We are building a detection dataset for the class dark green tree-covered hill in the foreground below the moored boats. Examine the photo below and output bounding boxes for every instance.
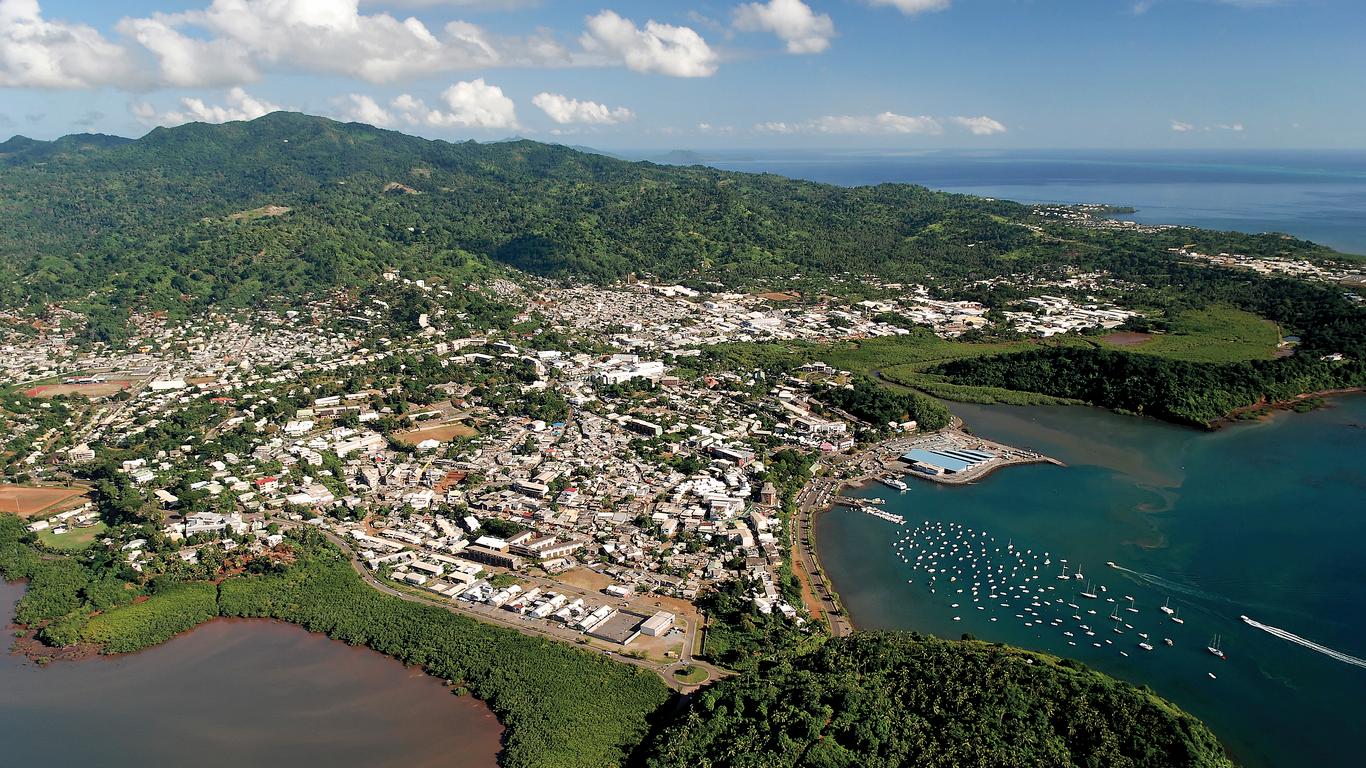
[642,633,1232,768]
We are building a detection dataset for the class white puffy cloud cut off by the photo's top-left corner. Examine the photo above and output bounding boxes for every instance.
[0,0,137,87]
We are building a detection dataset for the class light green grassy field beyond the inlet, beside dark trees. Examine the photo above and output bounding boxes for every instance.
[1101,306,1280,362]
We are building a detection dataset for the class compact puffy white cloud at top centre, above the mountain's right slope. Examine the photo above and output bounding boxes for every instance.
[579,11,716,78]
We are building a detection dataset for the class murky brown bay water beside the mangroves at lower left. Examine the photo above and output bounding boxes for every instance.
[0,582,503,768]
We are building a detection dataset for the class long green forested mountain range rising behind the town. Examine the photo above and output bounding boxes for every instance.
[0,112,1330,319]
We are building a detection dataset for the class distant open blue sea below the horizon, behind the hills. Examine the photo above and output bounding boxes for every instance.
[688,150,1366,256]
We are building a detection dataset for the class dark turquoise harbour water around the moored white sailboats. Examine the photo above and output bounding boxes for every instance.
[816,396,1366,768]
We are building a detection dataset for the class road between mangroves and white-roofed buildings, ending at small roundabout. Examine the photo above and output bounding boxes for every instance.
[307,529,731,693]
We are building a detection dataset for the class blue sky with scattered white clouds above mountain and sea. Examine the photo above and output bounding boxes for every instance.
[0,0,1366,150]
